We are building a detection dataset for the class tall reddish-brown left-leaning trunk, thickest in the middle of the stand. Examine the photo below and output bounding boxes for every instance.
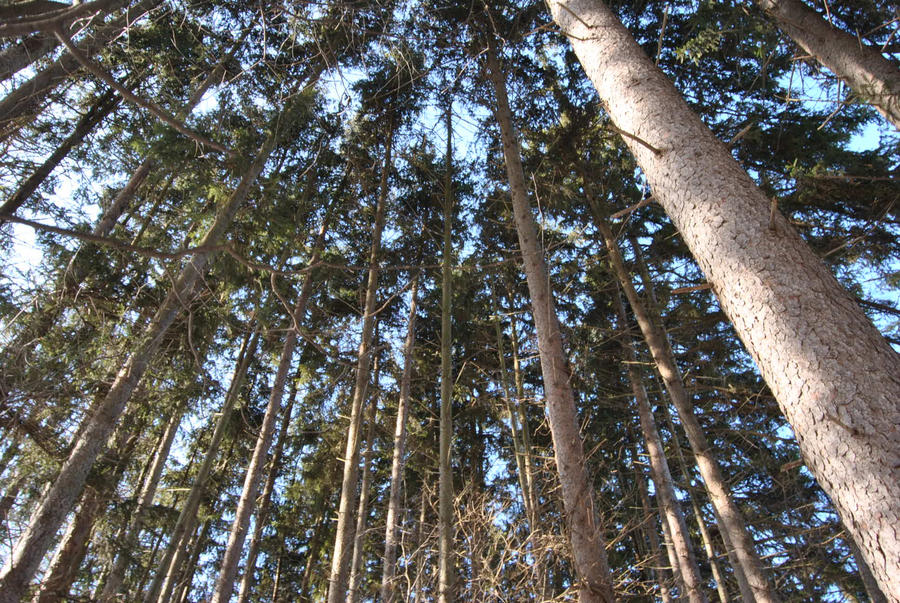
[487,48,615,603]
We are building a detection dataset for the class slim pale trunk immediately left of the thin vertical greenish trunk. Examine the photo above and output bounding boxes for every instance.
[381,272,420,603]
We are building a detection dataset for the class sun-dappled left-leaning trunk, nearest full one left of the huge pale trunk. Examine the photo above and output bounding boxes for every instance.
[589,217,778,603]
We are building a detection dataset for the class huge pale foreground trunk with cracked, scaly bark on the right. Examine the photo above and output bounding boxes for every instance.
[550,0,900,601]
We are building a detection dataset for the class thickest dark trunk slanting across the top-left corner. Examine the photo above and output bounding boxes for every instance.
[0,0,162,141]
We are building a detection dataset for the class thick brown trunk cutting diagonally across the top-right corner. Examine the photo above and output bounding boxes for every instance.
[756,0,900,129]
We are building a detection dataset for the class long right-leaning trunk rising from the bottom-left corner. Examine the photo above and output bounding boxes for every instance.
[0,112,277,603]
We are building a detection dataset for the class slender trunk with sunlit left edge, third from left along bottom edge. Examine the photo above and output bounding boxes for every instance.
[98,404,186,603]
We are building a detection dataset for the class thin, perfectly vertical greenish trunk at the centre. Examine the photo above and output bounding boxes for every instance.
[438,97,455,603]
